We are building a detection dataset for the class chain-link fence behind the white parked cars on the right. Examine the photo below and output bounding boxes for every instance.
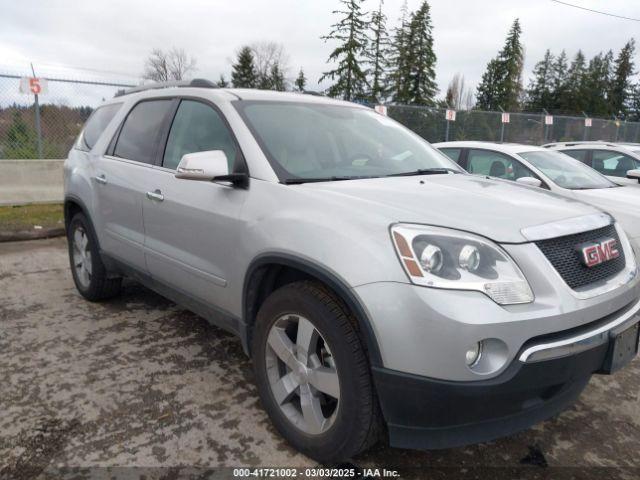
[387,105,640,145]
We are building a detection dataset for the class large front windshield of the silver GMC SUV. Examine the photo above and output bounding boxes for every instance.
[235,101,462,182]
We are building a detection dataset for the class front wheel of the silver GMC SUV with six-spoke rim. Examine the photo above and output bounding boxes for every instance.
[252,282,381,464]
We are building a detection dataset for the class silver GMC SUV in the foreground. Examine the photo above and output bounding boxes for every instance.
[65,80,640,462]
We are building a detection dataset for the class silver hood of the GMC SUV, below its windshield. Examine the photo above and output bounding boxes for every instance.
[296,174,598,243]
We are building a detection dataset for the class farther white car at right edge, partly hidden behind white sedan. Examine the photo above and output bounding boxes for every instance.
[543,142,640,186]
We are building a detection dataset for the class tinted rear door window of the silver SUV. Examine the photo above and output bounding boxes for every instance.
[113,99,172,163]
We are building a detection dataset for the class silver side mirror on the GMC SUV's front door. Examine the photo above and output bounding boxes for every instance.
[175,150,249,188]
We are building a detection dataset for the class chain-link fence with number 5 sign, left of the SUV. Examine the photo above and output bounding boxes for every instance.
[0,73,135,160]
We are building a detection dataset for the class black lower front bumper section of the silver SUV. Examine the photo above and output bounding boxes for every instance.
[373,316,638,449]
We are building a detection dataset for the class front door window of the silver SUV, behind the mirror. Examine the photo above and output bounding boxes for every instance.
[162,100,236,172]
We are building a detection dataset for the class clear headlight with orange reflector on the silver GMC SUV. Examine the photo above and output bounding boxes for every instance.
[391,224,533,305]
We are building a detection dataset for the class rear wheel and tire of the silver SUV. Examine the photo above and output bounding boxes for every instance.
[67,213,122,302]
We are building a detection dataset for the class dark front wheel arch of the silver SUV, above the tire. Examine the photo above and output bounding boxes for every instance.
[242,253,382,366]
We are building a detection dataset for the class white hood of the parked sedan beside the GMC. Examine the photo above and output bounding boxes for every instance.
[573,186,640,238]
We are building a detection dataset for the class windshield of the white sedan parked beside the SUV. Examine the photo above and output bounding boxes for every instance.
[518,151,617,190]
